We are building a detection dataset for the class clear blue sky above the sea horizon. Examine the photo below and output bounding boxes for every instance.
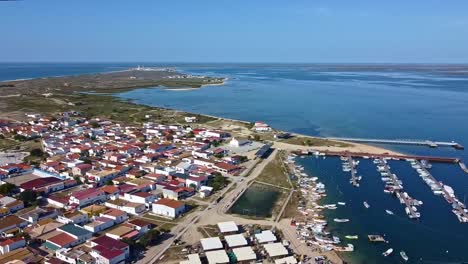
[0,0,468,63]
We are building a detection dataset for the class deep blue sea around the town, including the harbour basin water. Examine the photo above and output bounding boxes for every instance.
[0,63,468,263]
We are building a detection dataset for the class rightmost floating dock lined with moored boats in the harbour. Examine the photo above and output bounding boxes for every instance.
[411,161,468,223]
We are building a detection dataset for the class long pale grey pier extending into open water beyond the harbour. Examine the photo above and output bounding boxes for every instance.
[327,137,464,149]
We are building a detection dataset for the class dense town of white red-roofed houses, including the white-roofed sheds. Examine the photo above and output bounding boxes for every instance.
[0,108,352,264]
